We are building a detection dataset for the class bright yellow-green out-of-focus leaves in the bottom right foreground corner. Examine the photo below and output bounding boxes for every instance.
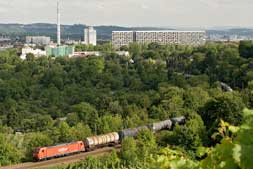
[200,110,253,169]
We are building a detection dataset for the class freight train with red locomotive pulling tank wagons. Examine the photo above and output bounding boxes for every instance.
[33,116,185,161]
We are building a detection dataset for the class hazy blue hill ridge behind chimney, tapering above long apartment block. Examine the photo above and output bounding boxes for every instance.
[0,23,172,40]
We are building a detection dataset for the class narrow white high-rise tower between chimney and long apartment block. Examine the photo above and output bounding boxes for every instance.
[84,27,97,46]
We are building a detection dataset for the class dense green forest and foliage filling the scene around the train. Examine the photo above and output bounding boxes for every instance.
[0,41,253,169]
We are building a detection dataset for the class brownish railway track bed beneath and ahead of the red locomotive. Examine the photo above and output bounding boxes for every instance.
[1,145,121,169]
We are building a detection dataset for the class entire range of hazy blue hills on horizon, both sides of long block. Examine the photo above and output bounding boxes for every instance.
[0,23,253,41]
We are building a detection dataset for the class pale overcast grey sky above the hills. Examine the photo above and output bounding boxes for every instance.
[0,0,253,28]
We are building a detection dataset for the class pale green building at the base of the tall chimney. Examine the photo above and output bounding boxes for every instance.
[45,45,75,57]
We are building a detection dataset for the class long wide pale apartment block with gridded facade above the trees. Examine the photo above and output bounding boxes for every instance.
[112,30,206,48]
